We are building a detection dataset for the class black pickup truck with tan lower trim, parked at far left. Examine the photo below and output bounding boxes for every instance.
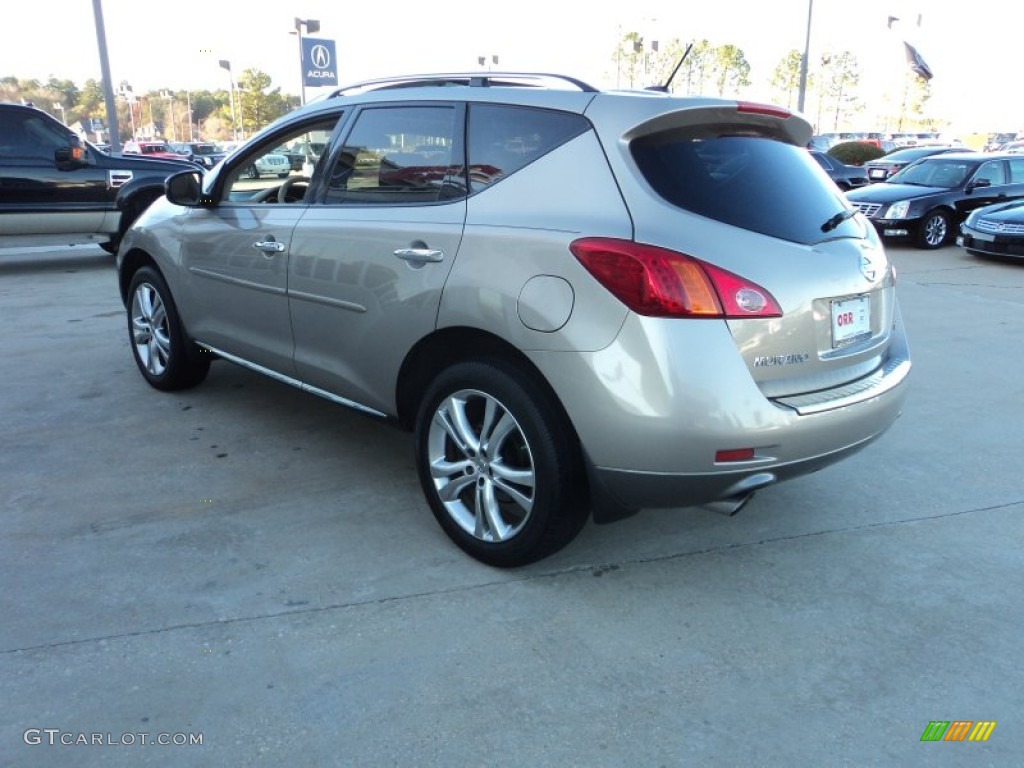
[0,103,198,253]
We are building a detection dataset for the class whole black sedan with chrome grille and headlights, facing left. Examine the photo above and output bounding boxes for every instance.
[846,153,1024,248]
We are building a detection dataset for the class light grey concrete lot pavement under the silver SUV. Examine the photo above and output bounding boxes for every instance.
[0,247,1024,767]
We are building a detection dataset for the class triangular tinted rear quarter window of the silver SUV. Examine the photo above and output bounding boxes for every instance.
[468,104,590,193]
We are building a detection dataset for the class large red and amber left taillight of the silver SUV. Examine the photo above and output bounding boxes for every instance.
[569,238,782,317]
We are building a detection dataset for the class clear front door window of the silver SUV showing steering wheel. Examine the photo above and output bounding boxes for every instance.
[221,116,340,203]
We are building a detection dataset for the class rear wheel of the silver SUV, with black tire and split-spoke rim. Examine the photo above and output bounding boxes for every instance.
[416,360,589,567]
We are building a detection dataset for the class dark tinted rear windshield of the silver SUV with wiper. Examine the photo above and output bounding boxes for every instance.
[631,133,863,244]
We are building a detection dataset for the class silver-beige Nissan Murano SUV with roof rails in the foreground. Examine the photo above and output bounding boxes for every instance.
[118,73,910,566]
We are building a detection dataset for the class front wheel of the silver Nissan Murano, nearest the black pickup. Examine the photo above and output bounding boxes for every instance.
[128,266,210,391]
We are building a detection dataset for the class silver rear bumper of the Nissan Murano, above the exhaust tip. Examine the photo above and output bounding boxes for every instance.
[535,313,910,519]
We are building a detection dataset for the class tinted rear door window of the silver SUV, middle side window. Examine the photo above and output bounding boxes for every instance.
[325,104,466,205]
